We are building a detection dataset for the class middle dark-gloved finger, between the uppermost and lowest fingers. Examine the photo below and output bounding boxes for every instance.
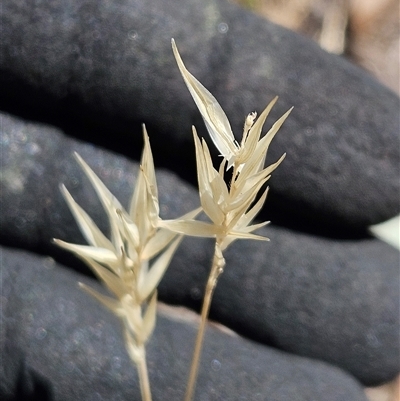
[0,116,400,385]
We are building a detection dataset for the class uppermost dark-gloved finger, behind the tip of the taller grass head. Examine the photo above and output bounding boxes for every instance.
[0,0,400,228]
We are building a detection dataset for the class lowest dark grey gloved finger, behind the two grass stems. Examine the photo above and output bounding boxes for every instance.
[0,248,367,401]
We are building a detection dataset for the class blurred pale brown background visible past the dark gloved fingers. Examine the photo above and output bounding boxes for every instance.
[231,0,400,401]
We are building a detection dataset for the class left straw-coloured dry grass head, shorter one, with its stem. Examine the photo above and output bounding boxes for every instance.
[54,127,200,400]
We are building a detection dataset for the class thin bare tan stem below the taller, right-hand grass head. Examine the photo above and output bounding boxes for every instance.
[185,241,225,401]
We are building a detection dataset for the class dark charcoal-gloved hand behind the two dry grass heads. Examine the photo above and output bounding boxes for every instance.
[0,0,399,400]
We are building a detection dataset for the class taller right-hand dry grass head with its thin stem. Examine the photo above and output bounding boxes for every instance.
[166,39,292,401]
